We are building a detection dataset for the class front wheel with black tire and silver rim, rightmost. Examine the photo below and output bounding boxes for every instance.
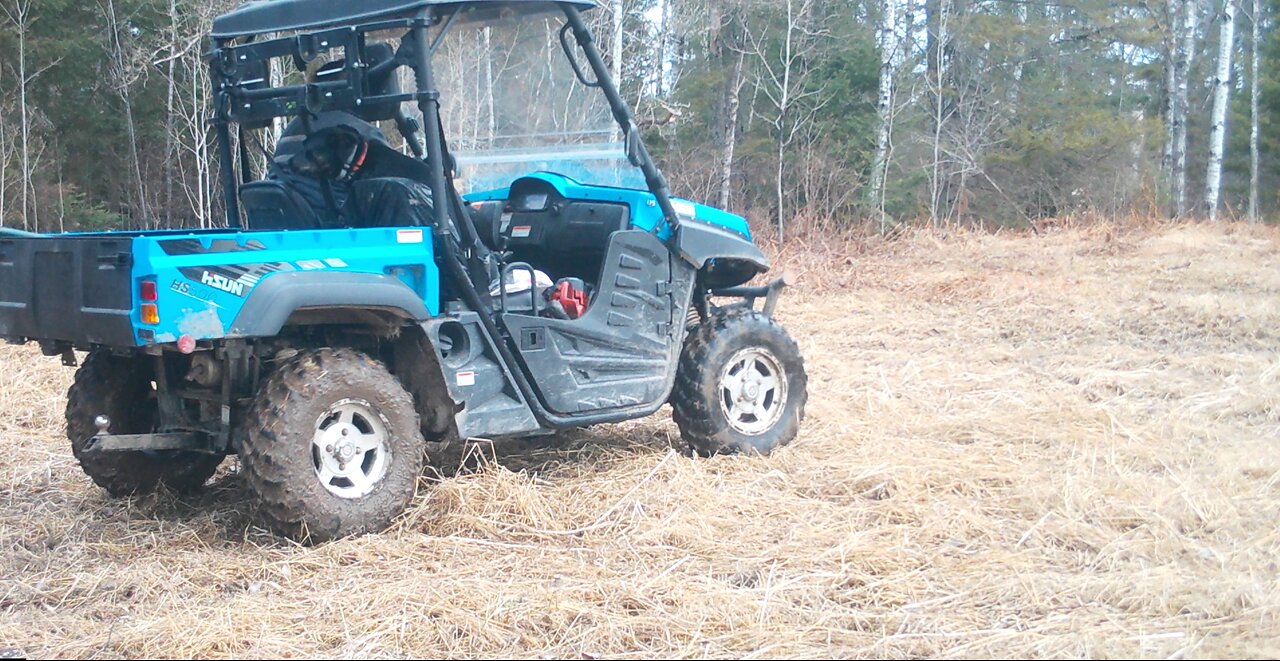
[671,310,808,457]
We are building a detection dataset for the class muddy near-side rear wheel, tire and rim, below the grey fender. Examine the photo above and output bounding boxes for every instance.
[241,348,426,543]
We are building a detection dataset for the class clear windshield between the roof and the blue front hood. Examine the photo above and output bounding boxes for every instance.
[434,17,646,193]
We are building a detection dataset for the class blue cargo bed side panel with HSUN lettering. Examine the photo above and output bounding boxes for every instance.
[133,228,440,346]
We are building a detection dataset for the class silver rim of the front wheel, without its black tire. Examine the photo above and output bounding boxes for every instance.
[719,347,787,436]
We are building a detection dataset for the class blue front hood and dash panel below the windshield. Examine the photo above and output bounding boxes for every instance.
[463,172,751,241]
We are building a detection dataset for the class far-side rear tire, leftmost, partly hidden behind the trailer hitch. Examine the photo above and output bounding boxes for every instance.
[67,351,223,497]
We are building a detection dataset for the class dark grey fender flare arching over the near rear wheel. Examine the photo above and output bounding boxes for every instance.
[229,272,431,337]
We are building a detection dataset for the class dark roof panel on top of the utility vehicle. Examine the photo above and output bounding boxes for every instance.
[212,0,595,38]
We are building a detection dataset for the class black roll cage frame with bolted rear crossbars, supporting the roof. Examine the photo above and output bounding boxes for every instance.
[206,3,680,237]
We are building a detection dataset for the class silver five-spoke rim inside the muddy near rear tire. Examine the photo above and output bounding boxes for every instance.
[311,400,392,500]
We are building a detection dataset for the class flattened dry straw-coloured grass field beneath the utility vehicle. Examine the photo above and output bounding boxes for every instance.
[0,225,1280,658]
